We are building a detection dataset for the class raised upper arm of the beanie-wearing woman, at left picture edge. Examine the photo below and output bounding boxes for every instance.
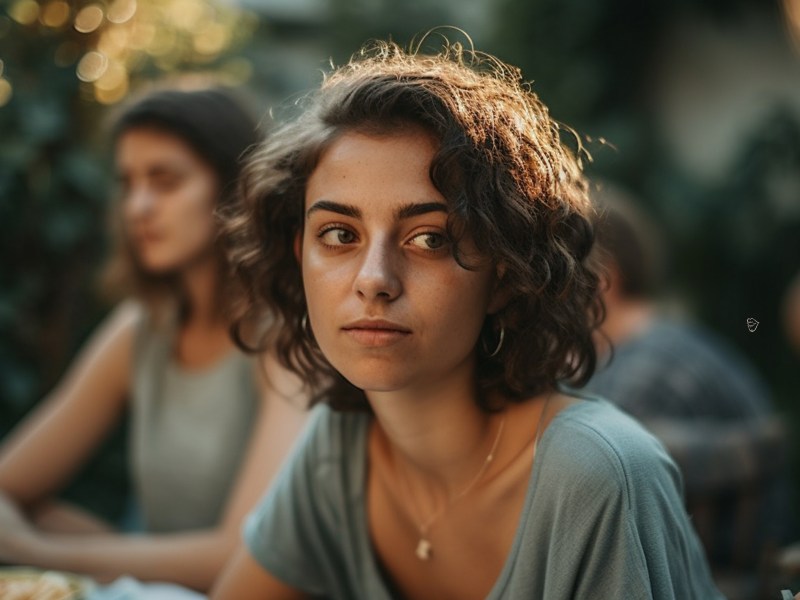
[0,303,140,510]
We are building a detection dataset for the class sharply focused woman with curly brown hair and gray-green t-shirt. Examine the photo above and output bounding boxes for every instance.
[212,43,720,600]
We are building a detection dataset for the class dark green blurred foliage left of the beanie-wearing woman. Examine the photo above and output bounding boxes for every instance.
[0,4,127,518]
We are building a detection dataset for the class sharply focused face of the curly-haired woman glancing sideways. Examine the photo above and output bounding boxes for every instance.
[298,129,499,392]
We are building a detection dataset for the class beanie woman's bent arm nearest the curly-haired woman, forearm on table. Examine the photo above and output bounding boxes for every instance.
[0,352,306,590]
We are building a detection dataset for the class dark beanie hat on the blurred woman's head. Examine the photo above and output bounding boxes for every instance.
[112,88,258,202]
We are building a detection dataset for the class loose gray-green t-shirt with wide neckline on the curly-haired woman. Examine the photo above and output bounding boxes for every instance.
[245,400,722,600]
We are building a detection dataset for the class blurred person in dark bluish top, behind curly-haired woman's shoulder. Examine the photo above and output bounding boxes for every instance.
[586,184,794,600]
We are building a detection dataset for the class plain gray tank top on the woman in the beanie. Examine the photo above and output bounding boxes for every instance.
[130,318,258,532]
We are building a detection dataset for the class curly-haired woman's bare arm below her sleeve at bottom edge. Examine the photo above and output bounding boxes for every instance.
[209,546,308,600]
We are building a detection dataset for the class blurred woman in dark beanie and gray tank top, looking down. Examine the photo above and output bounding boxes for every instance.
[0,84,304,589]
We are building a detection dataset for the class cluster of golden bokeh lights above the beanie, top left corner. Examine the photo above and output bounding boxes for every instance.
[0,0,258,104]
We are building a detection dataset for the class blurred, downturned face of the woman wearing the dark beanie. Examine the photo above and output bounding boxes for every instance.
[116,128,219,273]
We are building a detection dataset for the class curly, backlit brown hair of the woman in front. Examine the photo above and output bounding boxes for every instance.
[226,36,603,410]
